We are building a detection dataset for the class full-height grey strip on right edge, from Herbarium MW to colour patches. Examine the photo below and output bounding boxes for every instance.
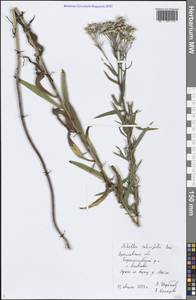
[186,0,196,300]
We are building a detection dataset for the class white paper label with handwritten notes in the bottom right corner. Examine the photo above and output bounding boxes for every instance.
[114,242,186,299]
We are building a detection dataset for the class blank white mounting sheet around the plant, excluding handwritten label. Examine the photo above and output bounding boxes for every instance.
[2,1,186,299]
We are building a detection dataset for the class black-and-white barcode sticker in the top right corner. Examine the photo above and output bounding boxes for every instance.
[156,8,178,22]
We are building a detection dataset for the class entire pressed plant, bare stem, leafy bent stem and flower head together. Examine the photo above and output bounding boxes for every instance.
[11,8,156,248]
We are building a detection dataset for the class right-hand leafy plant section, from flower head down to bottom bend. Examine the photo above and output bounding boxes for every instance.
[85,16,157,226]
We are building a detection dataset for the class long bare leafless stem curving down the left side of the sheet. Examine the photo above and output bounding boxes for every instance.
[12,9,71,249]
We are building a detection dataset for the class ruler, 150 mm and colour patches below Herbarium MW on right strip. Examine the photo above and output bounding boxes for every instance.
[186,87,196,299]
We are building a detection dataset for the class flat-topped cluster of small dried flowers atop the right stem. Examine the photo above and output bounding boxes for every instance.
[85,17,136,59]
